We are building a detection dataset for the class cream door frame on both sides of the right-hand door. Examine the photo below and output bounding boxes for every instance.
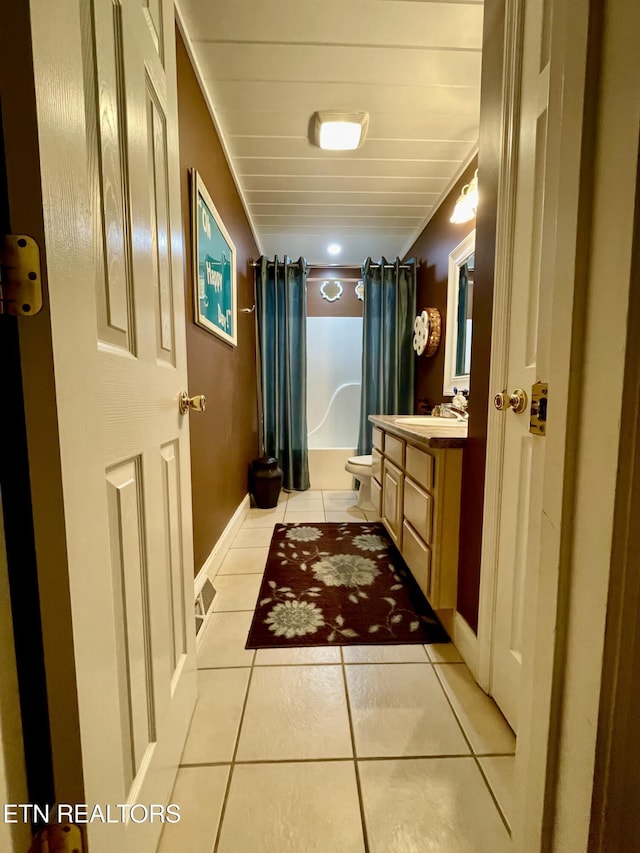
[478,0,640,853]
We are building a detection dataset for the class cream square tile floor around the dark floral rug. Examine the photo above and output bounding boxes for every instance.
[159,491,515,853]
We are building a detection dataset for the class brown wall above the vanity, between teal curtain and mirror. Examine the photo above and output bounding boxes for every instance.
[406,164,478,409]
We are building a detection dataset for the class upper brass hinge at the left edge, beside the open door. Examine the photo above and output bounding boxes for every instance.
[0,234,42,317]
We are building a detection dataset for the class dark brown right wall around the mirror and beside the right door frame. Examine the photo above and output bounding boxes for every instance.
[407,0,504,631]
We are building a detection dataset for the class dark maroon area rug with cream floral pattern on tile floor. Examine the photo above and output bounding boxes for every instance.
[246,522,449,649]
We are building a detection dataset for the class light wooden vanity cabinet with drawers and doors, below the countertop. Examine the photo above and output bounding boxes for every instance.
[372,427,462,610]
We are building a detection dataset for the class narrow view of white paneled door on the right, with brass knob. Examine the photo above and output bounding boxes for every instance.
[490,3,549,730]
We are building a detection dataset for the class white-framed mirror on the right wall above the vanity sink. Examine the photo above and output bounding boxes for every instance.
[443,229,476,396]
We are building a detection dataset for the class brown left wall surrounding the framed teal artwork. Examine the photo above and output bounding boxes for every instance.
[176,32,259,573]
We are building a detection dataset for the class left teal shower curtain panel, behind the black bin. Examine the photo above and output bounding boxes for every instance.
[256,257,309,491]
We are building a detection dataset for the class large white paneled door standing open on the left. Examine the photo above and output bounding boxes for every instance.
[23,0,196,853]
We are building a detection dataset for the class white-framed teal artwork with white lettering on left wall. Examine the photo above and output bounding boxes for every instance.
[191,169,238,347]
